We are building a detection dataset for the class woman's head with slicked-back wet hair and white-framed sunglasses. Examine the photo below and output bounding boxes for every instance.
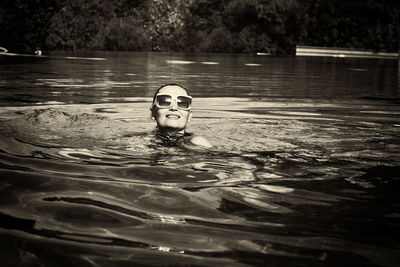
[150,84,192,132]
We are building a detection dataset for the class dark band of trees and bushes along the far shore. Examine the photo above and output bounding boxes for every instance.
[0,0,400,54]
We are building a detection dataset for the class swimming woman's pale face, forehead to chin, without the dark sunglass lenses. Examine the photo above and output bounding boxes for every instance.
[151,85,192,133]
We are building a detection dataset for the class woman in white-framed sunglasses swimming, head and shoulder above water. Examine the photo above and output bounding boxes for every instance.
[150,84,212,148]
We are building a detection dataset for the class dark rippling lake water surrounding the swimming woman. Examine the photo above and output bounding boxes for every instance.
[0,53,400,266]
